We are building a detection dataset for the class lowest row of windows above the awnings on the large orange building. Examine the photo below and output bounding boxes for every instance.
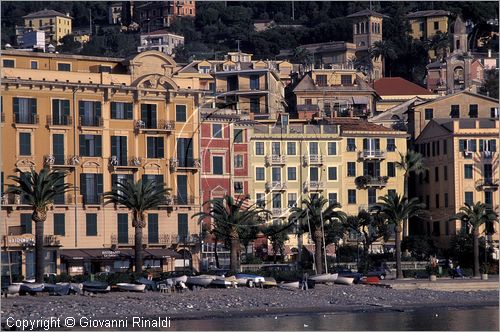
[20,213,189,243]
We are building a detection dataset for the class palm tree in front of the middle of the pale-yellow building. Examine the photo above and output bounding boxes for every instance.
[289,196,346,274]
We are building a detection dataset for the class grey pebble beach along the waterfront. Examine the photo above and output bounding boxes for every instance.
[1,285,499,325]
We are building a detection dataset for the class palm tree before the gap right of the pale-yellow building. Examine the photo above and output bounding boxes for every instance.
[374,192,424,279]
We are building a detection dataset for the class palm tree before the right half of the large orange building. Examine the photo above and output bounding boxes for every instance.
[104,180,168,272]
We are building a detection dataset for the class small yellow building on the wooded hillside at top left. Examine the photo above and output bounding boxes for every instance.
[17,9,73,46]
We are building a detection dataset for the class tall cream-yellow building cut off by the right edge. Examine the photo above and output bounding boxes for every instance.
[415,118,500,254]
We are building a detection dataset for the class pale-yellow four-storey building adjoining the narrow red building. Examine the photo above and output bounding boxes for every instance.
[249,118,407,255]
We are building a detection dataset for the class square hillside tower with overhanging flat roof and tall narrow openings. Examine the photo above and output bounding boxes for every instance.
[347,9,388,79]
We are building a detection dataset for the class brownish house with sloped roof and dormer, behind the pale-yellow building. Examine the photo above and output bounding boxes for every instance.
[293,69,379,117]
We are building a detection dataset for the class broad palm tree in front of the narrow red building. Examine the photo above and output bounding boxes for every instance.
[192,195,269,271]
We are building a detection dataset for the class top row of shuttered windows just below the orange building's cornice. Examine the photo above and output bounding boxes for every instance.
[12,97,187,123]
